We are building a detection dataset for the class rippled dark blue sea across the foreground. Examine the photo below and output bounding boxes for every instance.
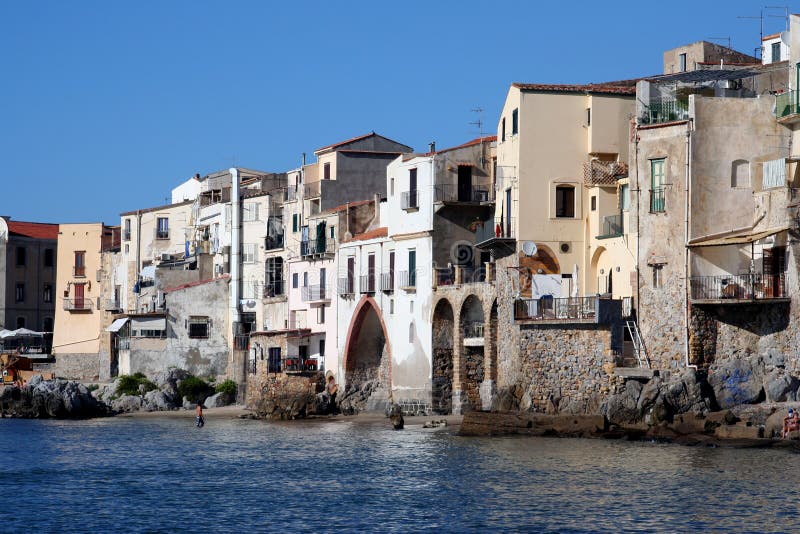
[0,416,800,532]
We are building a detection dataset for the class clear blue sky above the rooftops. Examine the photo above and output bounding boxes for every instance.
[0,0,791,224]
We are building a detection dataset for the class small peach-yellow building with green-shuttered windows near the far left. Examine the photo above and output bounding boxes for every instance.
[53,223,119,379]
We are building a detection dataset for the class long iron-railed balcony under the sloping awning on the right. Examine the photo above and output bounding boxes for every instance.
[689,273,789,304]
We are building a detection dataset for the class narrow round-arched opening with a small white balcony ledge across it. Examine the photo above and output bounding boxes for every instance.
[459,295,486,411]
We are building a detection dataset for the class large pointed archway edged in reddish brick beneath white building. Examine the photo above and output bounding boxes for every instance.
[342,296,392,411]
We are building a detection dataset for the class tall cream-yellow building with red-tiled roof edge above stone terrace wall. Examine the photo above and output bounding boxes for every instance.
[477,81,636,297]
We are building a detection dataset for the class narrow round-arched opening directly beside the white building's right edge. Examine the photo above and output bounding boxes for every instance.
[431,299,454,414]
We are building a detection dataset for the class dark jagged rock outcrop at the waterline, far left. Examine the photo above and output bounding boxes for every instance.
[0,375,111,419]
